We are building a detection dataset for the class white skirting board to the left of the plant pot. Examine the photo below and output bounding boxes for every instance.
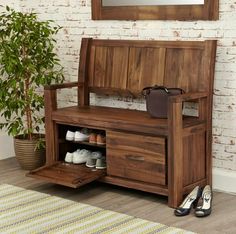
[0,134,15,160]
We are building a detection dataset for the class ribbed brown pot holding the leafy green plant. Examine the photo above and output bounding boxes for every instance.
[14,136,46,170]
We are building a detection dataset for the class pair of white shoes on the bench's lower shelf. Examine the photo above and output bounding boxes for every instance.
[65,149,91,164]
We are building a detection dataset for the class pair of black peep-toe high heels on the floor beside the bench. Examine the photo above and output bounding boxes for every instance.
[174,185,213,217]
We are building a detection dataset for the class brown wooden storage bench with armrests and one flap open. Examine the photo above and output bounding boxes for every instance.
[30,38,216,207]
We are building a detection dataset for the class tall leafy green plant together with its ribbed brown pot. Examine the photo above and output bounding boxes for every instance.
[0,7,64,170]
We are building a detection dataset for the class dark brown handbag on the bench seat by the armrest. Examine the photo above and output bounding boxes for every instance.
[142,85,184,118]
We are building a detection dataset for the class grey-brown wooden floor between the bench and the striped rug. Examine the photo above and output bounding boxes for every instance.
[0,158,236,234]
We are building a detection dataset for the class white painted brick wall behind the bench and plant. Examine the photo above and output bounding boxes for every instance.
[1,0,236,171]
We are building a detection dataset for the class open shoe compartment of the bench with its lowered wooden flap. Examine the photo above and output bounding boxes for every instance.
[27,123,106,188]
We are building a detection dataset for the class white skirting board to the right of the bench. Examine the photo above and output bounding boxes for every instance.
[212,168,236,194]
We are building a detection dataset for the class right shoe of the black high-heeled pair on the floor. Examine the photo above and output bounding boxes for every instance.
[195,185,212,217]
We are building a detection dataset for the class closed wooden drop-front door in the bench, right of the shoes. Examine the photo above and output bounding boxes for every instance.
[107,132,166,185]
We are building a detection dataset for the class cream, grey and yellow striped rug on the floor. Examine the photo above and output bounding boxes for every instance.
[0,184,195,234]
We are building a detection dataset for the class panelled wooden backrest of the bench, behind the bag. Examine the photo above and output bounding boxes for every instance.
[79,38,216,105]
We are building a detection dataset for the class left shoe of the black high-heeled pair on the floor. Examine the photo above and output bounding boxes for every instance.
[174,186,201,216]
